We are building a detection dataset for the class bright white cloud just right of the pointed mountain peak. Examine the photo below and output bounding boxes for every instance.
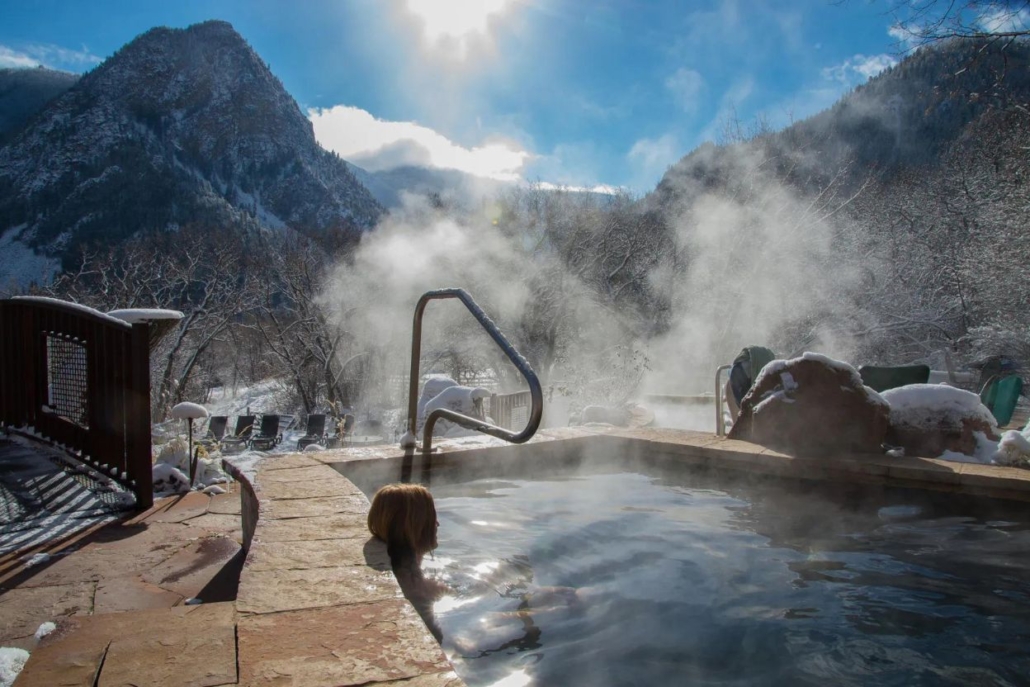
[308,105,531,181]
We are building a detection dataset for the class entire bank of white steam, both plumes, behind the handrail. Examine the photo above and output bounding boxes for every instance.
[323,143,857,420]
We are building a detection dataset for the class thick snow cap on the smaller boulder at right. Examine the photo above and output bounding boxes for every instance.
[883,384,997,430]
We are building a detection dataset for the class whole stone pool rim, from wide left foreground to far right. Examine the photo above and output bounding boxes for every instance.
[219,427,1030,687]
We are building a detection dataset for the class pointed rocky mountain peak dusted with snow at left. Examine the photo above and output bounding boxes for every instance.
[0,22,383,271]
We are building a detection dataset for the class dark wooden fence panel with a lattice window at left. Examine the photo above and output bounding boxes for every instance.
[0,298,153,509]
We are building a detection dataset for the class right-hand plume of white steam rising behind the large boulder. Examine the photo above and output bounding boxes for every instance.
[645,146,857,393]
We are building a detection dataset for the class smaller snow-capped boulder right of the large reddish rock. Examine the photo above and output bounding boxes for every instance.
[883,384,998,462]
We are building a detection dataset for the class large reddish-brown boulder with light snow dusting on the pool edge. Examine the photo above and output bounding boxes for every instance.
[729,353,890,455]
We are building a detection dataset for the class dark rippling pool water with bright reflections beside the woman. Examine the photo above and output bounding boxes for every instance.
[425,474,1030,687]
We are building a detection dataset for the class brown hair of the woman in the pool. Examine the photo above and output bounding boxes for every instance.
[369,484,437,556]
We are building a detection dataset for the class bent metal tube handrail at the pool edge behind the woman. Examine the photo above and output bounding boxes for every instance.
[401,288,544,453]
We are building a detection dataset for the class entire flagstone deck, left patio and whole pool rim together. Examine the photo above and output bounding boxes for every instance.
[10,430,1030,687]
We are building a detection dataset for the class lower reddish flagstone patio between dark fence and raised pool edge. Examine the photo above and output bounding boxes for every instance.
[0,485,243,651]
